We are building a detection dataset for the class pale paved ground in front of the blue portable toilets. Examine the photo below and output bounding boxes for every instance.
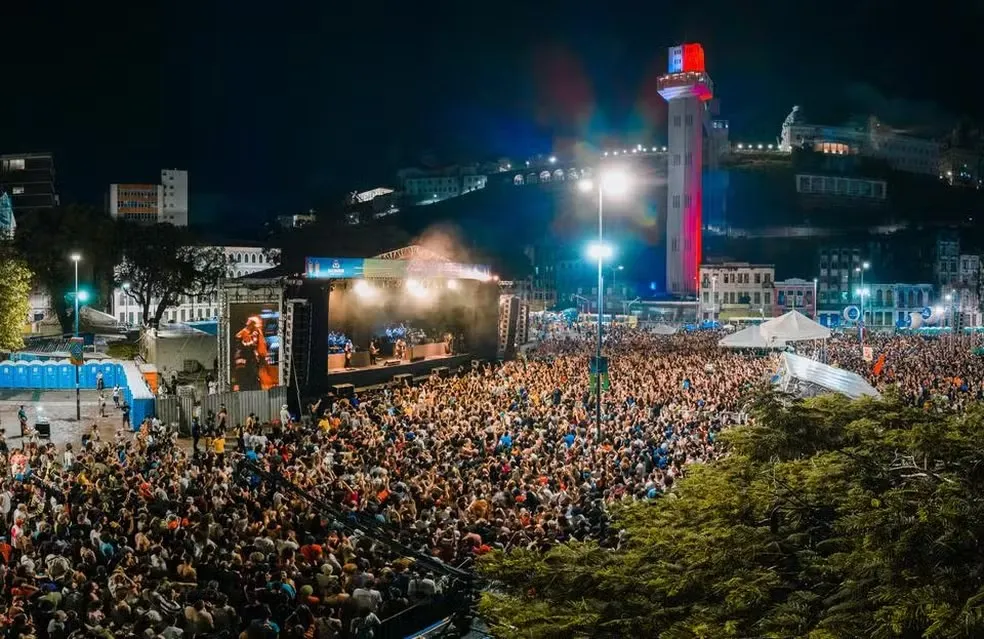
[0,388,136,450]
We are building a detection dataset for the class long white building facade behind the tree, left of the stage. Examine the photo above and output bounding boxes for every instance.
[111,246,279,326]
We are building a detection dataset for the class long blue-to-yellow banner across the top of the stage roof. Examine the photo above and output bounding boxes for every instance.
[304,257,491,281]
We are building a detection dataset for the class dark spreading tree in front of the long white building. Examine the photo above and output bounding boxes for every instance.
[114,224,226,328]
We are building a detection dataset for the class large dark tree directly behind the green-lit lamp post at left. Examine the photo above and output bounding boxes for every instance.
[14,204,120,333]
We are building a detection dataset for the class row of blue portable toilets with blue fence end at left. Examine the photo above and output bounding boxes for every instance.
[0,359,154,429]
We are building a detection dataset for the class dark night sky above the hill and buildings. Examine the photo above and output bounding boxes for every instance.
[0,0,984,222]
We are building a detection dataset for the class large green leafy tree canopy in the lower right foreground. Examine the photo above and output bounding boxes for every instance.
[479,394,984,639]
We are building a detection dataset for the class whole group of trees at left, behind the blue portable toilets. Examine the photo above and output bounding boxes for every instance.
[6,204,225,338]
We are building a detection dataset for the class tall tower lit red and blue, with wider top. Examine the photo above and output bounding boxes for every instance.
[658,44,714,295]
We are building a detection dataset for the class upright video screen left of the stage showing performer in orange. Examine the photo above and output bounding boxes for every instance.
[229,302,280,391]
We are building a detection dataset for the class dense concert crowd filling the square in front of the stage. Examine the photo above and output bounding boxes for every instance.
[0,325,984,639]
